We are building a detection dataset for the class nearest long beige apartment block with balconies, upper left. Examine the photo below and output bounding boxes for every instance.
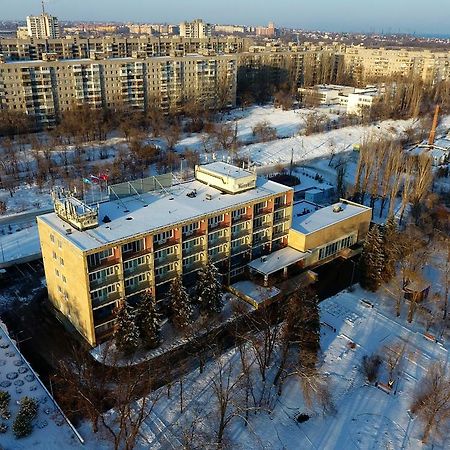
[0,55,237,125]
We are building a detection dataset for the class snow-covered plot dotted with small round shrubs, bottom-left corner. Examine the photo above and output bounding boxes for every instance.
[0,321,83,450]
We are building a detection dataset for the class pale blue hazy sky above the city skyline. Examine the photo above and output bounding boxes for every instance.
[0,0,450,34]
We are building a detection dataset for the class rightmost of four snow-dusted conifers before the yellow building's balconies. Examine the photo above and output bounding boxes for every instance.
[197,263,223,315]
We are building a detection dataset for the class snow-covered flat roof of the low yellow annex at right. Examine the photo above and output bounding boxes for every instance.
[292,201,370,234]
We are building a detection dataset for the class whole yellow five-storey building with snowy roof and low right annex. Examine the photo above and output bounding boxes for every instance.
[38,162,371,346]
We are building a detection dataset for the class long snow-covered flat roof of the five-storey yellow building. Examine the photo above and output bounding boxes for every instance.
[38,178,292,251]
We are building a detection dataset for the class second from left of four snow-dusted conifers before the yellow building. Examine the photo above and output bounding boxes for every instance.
[136,292,161,348]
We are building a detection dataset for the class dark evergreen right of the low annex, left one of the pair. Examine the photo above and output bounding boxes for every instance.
[359,225,384,292]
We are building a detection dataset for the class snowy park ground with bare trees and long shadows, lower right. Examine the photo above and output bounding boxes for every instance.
[86,288,450,450]
